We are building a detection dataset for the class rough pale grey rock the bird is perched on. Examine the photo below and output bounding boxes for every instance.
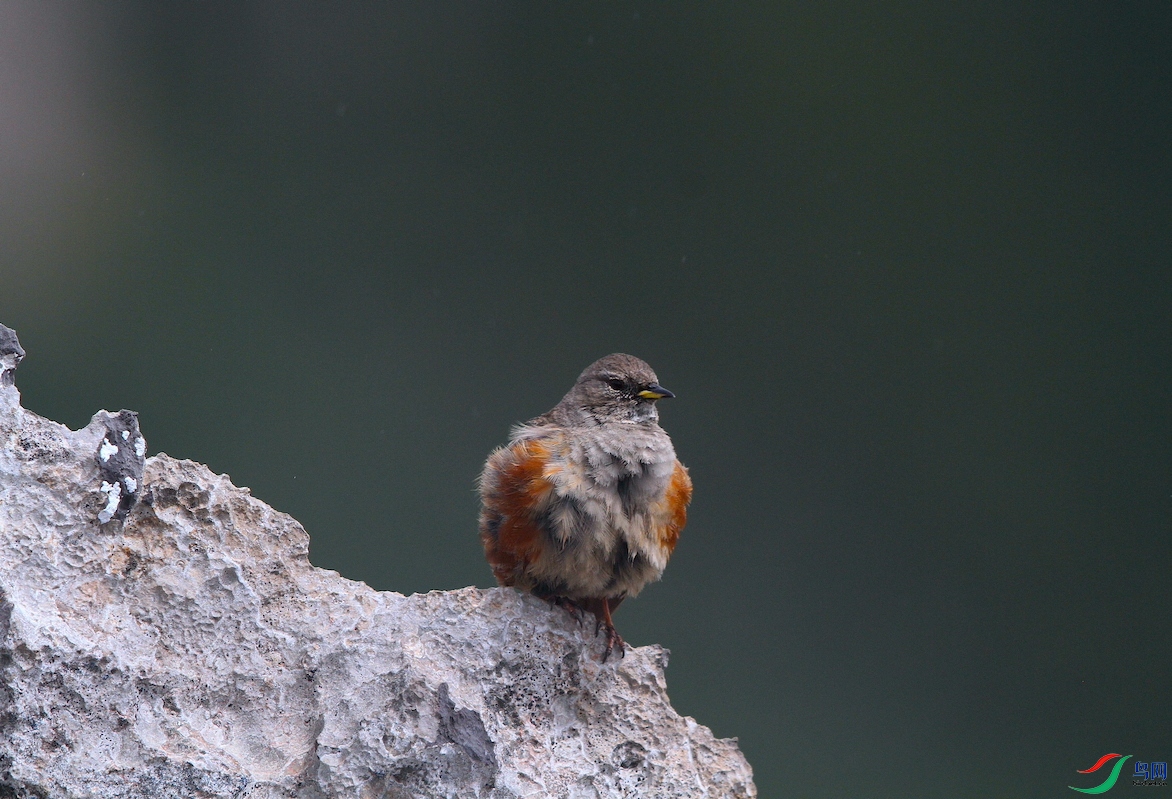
[0,326,756,799]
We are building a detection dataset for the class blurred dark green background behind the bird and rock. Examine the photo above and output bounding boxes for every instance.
[0,0,1172,799]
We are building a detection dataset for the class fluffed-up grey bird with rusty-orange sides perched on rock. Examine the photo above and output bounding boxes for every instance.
[478,353,691,663]
